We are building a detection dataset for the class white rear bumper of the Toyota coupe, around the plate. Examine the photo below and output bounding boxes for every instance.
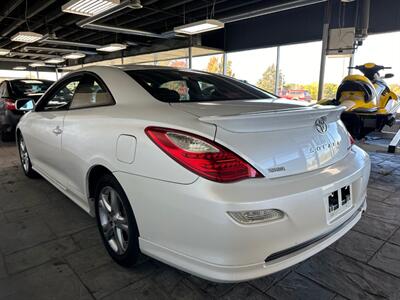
[115,146,370,282]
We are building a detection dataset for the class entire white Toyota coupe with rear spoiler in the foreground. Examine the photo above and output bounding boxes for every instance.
[16,66,370,282]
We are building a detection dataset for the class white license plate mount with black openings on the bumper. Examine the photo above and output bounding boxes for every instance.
[327,185,353,221]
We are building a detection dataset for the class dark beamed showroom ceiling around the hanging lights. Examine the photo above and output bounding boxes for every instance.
[0,0,310,67]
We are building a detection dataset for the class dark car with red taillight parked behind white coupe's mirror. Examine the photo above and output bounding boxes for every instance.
[0,79,53,141]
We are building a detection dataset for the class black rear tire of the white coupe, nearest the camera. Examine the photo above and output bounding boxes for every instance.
[95,174,140,267]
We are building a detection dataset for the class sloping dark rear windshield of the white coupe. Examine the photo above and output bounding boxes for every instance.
[126,69,276,102]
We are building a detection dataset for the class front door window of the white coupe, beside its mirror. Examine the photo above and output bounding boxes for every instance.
[39,78,79,111]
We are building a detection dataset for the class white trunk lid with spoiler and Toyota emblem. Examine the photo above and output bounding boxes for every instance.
[171,99,351,178]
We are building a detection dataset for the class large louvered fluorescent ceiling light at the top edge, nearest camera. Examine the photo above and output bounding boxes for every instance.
[61,0,120,17]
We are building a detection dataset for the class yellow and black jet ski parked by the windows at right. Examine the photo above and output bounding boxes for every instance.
[318,63,400,139]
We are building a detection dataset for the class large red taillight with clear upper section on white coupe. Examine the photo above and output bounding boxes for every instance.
[145,127,263,182]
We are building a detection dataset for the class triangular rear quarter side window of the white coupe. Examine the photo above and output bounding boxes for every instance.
[70,75,115,109]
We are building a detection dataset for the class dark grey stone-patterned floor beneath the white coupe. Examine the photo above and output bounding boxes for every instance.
[0,144,400,300]
